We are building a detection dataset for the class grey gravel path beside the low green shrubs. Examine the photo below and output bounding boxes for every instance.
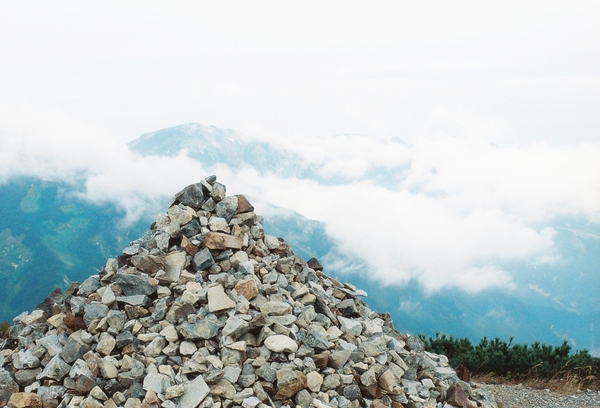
[473,383,600,408]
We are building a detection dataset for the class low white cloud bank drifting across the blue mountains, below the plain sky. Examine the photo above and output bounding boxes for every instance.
[0,108,600,292]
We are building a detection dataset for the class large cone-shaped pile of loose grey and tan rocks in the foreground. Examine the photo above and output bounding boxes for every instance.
[0,176,496,408]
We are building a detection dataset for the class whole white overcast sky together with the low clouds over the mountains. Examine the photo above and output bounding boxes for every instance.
[0,0,600,291]
